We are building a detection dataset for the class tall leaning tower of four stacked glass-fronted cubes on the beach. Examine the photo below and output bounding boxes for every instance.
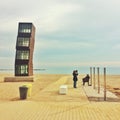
[15,23,35,76]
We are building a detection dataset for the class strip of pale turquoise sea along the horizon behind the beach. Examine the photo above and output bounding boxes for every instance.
[0,66,120,75]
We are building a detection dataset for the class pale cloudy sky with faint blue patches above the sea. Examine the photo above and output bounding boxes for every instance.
[0,0,120,68]
